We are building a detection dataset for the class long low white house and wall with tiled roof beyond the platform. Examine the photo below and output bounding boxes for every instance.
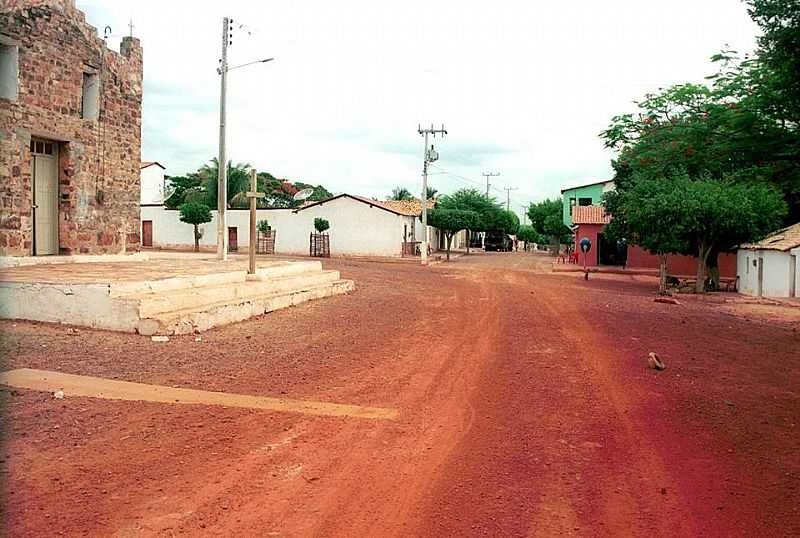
[141,194,465,257]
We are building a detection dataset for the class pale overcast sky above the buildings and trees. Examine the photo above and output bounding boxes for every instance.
[77,0,757,218]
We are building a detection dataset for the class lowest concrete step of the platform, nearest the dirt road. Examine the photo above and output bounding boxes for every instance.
[137,278,354,336]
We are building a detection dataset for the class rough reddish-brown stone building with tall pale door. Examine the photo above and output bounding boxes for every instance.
[0,0,142,256]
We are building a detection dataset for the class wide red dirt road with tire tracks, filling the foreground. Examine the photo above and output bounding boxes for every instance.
[0,253,800,536]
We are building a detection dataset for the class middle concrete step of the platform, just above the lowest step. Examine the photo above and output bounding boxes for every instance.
[128,271,339,318]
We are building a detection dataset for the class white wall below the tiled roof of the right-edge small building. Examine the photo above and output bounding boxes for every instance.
[736,249,797,297]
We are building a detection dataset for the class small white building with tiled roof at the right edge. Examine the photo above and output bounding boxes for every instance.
[736,223,800,297]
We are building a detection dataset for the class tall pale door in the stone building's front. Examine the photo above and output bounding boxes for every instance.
[31,140,58,256]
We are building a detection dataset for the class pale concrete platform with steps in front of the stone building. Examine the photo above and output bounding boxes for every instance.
[0,253,354,336]
